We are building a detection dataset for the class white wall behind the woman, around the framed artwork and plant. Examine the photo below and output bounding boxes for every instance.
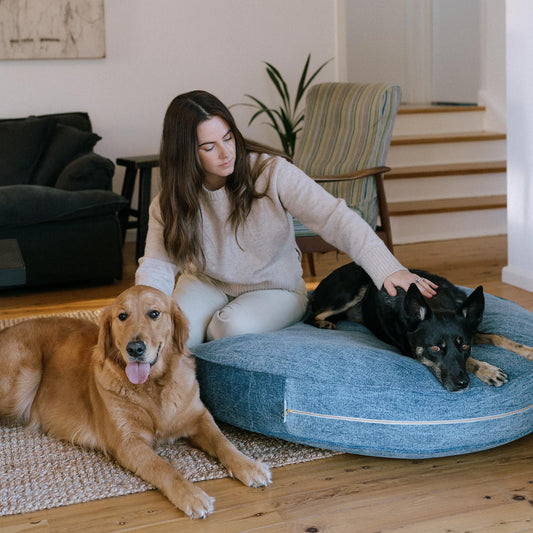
[0,0,338,184]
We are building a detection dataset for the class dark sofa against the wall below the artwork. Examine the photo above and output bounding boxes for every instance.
[0,112,128,286]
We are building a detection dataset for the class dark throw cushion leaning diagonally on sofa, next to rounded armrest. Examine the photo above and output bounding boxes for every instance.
[30,123,101,188]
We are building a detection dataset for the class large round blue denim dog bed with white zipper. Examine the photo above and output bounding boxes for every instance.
[194,294,533,458]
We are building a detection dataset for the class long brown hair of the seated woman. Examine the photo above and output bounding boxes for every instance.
[159,91,286,270]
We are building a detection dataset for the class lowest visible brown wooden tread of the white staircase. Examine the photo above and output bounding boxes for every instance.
[388,194,507,216]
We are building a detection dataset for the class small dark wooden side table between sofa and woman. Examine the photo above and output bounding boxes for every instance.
[116,155,159,259]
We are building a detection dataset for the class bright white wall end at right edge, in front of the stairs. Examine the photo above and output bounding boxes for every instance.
[503,0,533,291]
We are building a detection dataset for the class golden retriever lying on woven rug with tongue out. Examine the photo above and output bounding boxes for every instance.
[0,286,270,518]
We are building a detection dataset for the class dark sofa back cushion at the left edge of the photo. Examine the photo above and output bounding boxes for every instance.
[0,118,54,185]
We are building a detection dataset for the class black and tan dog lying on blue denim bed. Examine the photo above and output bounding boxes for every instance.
[306,263,533,392]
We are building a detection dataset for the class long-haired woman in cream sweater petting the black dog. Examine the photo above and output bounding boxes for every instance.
[136,91,436,347]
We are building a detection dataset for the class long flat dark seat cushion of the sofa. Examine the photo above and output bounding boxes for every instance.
[0,185,128,227]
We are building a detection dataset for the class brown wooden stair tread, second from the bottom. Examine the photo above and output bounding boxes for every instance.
[385,161,507,180]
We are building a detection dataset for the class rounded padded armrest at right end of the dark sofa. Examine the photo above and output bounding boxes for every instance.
[55,152,115,191]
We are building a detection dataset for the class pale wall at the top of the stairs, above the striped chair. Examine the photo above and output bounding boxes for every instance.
[346,0,505,113]
